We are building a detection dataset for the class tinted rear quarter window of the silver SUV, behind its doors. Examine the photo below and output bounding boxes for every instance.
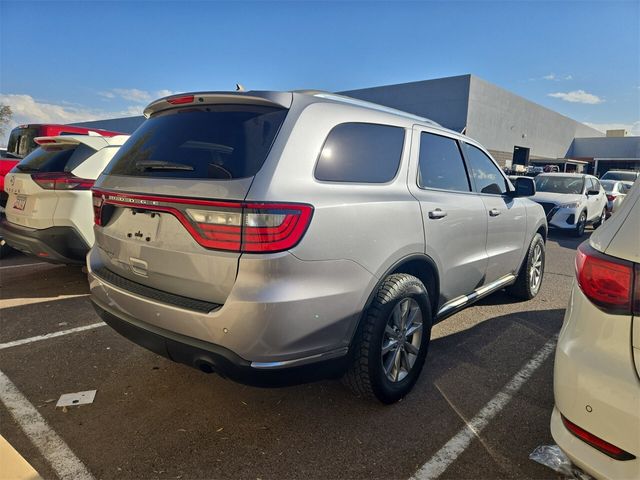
[315,123,404,183]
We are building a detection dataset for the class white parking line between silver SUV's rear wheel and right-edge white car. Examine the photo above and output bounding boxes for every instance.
[411,335,558,480]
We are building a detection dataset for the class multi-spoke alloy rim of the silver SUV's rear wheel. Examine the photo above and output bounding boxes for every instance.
[381,297,423,383]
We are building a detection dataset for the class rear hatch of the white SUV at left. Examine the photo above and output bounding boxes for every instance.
[5,136,106,229]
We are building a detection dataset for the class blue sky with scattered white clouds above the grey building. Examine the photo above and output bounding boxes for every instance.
[0,0,640,143]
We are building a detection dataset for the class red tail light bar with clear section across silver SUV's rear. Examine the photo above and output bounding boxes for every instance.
[93,190,313,253]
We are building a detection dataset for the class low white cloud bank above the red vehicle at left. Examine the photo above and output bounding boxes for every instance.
[0,94,142,145]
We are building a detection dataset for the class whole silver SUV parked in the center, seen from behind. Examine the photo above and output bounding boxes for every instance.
[87,92,547,403]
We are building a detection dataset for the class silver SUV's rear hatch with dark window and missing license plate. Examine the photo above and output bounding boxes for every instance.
[92,94,291,304]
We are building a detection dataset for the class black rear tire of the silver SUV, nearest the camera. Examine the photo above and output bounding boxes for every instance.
[343,273,432,404]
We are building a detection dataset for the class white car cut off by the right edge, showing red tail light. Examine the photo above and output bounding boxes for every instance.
[551,182,640,479]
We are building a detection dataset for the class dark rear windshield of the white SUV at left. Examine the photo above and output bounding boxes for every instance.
[16,144,96,172]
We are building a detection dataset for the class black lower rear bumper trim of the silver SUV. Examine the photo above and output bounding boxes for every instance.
[93,300,347,387]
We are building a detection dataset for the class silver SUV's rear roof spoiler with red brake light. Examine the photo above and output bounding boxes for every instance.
[143,91,293,118]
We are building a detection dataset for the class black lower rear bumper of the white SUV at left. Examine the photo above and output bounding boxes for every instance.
[0,218,89,265]
